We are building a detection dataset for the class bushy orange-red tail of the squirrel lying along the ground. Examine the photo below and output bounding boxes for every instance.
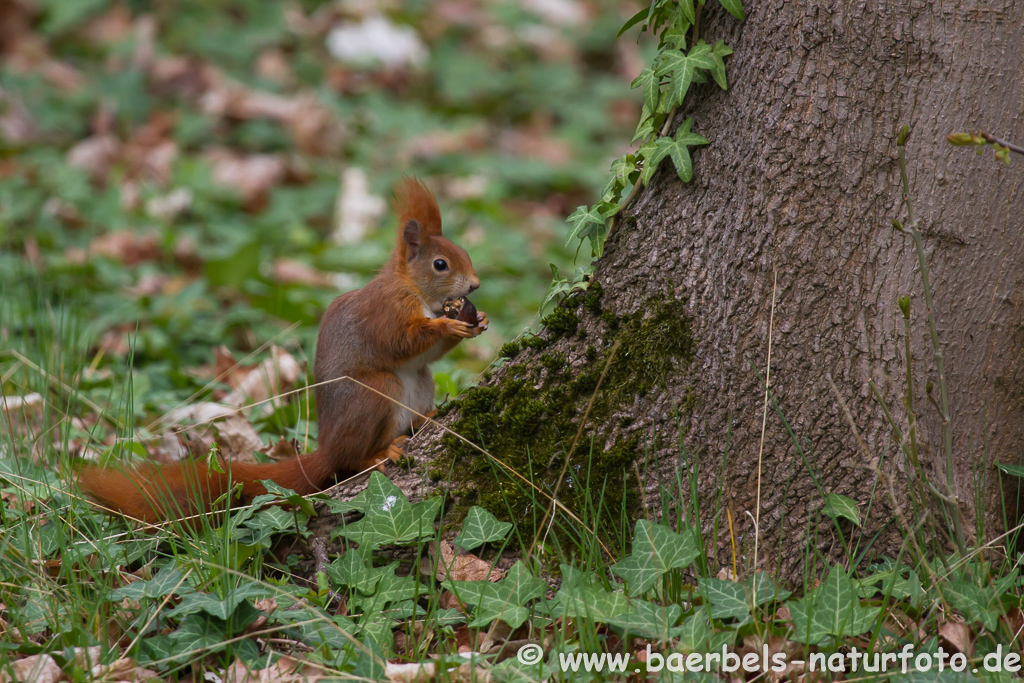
[78,451,334,523]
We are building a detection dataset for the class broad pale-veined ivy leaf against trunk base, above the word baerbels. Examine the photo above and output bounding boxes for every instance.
[611,519,699,595]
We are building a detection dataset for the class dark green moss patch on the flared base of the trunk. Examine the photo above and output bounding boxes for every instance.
[435,290,693,539]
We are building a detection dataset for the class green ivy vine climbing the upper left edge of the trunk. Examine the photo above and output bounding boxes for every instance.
[561,0,745,268]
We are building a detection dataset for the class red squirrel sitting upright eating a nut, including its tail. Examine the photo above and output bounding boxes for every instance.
[79,178,487,522]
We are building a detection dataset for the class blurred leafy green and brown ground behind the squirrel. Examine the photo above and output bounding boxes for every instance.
[0,0,653,444]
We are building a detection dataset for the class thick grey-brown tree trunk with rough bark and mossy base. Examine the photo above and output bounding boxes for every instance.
[387,0,1024,579]
